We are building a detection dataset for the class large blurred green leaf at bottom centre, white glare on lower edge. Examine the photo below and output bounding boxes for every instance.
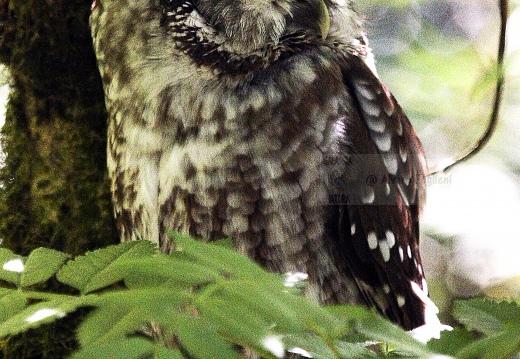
[195,279,344,357]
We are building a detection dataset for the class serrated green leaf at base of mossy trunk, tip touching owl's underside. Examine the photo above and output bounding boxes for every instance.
[57,241,156,294]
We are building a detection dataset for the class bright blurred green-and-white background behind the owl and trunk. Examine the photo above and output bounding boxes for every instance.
[0,0,520,320]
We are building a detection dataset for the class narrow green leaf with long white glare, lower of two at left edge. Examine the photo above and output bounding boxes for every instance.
[0,296,91,337]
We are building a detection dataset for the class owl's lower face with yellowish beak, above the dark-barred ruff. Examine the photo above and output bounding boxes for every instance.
[194,0,330,54]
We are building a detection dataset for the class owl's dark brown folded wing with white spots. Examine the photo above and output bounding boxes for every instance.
[337,56,436,329]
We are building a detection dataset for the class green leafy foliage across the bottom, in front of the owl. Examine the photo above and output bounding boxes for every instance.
[0,234,520,359]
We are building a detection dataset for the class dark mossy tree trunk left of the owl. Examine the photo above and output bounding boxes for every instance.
[0,0,117,359]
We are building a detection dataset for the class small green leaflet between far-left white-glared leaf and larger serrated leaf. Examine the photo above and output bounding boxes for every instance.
[20,248,69,288]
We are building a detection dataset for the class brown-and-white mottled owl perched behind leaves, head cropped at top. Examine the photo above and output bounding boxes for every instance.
[91,0,439,338]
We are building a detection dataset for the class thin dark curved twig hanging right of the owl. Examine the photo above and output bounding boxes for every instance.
[428,0,509,175]
